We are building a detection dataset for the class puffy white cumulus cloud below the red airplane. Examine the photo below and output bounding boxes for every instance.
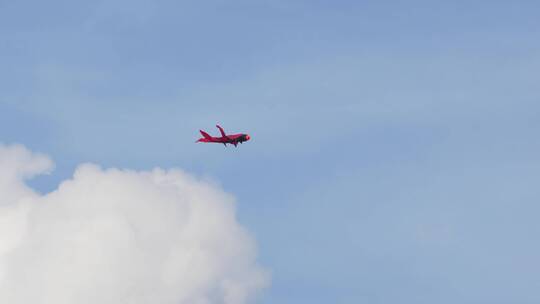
[0,146,268,304]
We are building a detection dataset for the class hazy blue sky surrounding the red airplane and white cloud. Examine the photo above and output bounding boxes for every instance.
[0,0,540,304]
